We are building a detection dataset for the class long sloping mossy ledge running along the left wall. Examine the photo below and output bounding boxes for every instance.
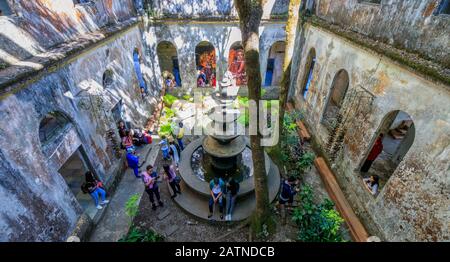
[0,18,138,100]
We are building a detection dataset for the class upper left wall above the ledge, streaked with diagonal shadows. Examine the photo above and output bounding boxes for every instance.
[0,0,135,64]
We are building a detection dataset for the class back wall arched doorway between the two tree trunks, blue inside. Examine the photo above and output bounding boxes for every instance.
[264,41,286,86]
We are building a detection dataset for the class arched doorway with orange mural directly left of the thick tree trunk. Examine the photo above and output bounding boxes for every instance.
[228,42,247,86]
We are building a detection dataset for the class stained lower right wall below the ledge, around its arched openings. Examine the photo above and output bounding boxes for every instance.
[293,24,450,241]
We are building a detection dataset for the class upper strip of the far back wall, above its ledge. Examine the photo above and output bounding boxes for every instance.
[148,0,289,19]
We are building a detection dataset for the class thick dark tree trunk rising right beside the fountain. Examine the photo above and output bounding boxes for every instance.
[234,0,273,237]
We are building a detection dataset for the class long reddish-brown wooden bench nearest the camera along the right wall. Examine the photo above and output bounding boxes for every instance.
[314,157,369,242]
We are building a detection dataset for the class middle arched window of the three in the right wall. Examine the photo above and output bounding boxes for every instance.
[322,69,349,129]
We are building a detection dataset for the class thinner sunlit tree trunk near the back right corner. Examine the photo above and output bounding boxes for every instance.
[279,0,302,137]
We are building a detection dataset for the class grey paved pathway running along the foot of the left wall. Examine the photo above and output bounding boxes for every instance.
[89,140,160,242]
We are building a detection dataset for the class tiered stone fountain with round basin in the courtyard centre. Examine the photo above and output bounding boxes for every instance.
[174,78,280,221]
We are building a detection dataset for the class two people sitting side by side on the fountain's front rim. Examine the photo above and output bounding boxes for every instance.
[208,177,239,221]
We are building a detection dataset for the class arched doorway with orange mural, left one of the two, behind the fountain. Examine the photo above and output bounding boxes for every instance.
[195,41,216,87]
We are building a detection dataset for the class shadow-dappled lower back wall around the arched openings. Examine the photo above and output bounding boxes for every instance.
[144,21,286,88]
